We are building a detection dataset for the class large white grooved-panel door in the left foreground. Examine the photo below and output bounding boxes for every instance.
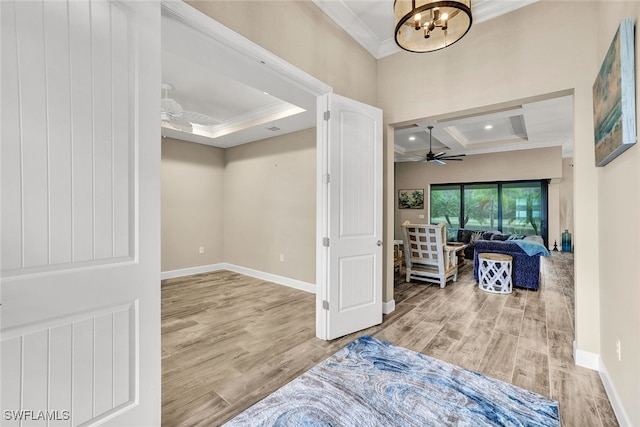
[0,0,161,426]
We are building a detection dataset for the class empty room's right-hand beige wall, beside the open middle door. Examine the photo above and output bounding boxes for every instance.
[223,129,316,283]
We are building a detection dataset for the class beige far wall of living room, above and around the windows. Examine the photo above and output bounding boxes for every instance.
[394,147,562,243]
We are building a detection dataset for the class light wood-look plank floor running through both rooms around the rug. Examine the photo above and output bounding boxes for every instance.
[162,253,618,427]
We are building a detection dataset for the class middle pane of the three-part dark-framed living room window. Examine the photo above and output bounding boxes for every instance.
[464,184,498,230]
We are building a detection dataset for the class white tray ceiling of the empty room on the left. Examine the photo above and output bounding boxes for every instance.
[158,11,316,148]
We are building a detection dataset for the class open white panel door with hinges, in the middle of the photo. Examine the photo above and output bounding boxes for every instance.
[316,94,383,339]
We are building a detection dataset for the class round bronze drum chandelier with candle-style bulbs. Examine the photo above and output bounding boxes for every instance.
[393,0,472,52]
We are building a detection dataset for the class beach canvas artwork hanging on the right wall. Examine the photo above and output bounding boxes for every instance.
[593,19,636,166]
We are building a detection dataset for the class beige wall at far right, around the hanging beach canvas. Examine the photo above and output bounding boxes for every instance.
[596,2,640,426]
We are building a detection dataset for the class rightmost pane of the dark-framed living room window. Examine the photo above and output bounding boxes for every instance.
[502,182,542,236]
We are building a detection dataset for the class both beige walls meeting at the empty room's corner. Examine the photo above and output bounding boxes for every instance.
[162,129,316,283]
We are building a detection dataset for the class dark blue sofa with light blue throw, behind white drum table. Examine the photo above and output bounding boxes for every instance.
[473,240,549,290]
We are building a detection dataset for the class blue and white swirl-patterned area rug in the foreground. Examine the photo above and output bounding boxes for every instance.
[225,336,560,426]
